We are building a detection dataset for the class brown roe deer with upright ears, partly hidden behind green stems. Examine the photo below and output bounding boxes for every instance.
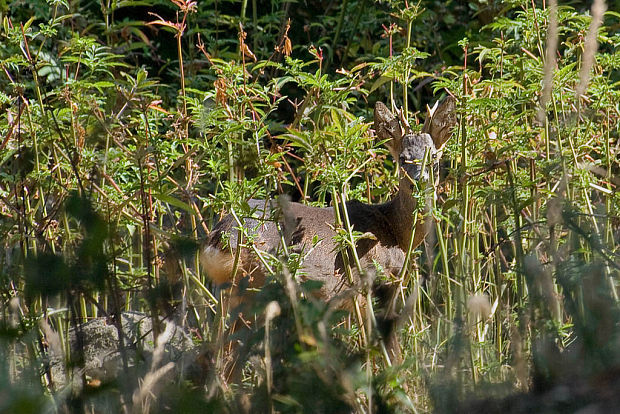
[201,97,456,360]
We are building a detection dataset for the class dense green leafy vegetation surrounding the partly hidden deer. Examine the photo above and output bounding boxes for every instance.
[0,0,620,413]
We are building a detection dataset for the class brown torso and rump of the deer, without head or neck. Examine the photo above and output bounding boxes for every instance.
[202,192,426,306]
